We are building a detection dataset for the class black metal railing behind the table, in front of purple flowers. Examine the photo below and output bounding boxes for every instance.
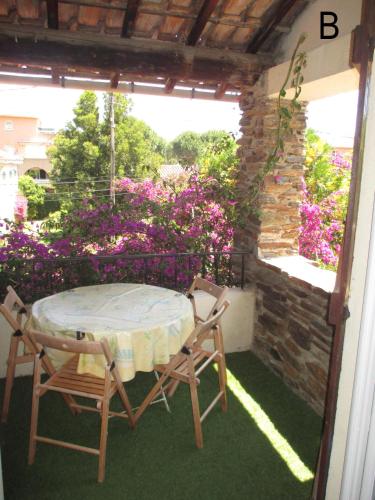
[0,251,253,301]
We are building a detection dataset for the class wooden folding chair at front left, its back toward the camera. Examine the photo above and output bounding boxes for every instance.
[28,330,135,482]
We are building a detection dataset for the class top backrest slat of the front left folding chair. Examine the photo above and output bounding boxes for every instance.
[27,329,113,365]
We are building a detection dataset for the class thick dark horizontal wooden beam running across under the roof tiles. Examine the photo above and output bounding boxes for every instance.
[0,25,273,83]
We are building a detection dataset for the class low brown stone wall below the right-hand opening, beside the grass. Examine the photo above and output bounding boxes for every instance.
[248,260,333,415]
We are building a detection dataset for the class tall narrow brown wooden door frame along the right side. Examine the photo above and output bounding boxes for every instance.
[313,0,375,500]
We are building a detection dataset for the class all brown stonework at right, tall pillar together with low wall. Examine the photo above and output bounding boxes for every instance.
[235,77,333,415]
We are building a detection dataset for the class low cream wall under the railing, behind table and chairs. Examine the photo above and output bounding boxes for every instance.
[0,288,255,378]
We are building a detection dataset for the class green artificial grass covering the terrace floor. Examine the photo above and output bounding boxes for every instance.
[1,352,321,500]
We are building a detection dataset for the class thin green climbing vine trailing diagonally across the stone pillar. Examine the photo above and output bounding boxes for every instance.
[247,34,306,215]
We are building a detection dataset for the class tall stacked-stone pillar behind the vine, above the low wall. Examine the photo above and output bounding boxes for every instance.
[236,77,306,257]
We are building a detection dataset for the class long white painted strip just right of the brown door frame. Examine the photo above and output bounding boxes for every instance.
[326,52,375,500]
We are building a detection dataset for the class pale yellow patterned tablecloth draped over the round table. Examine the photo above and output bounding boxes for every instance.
[30,283,194,382]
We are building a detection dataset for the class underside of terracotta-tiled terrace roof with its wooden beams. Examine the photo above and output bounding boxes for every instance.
[0,0,309,100]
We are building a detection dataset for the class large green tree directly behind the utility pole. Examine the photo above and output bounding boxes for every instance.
[48,91,165,208]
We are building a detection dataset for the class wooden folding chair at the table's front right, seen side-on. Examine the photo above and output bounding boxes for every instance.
[135,301,229,448]
